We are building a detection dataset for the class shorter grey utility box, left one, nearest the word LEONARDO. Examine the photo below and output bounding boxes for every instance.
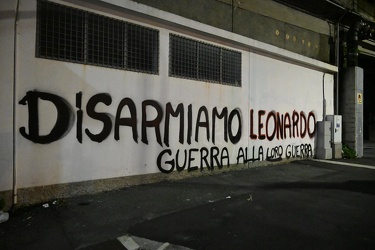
[316,121,332,159]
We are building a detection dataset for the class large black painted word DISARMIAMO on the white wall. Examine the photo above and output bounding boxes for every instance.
[19,91,242,147]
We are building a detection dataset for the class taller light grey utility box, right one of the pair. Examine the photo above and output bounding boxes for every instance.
[326,115,342,159]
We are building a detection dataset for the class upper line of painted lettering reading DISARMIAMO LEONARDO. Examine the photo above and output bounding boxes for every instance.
[19,91,316,147]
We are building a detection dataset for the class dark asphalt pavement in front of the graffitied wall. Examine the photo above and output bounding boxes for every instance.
[0,144,375,250]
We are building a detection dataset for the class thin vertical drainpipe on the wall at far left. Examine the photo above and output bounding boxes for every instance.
[12,0,20,210]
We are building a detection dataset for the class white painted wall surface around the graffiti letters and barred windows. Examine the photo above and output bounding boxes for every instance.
[0,1,333,190]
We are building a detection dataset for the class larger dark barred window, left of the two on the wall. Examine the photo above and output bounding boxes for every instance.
[36,0,159,74]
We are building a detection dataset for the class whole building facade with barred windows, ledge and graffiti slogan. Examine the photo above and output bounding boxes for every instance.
[0,0,374,207]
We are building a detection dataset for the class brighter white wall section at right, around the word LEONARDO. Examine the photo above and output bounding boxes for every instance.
[248,54,334,161]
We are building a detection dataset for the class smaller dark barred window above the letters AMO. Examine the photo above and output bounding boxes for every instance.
[169,34,241,87]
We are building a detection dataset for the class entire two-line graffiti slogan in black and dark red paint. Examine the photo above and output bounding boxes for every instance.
[19,91,316,173]
